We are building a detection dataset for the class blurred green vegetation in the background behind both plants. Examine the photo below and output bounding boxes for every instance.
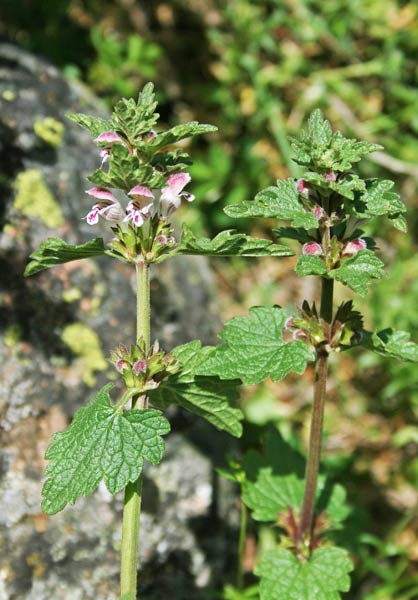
[0,0,418,600]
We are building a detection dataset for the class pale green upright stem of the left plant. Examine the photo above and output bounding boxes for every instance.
[120,264,151,600]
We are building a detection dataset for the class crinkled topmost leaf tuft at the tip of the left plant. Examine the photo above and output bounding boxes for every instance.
[111,83,160,140]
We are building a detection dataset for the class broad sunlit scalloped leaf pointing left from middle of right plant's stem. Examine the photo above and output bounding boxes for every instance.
[200,306,314,383]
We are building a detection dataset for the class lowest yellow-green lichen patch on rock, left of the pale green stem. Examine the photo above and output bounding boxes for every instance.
[62,323,108,386]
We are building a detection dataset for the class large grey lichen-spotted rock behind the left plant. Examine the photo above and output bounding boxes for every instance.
[0,44,234,600]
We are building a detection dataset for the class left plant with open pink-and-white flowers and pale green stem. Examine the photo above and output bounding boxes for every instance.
[25,83,292,600]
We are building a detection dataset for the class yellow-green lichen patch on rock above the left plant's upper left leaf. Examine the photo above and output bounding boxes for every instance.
[14,169,64,229]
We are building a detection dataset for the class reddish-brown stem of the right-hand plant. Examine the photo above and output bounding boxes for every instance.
[299,278,334,541]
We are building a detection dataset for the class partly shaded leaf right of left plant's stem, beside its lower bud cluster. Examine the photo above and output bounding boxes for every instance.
[149,340,243,437]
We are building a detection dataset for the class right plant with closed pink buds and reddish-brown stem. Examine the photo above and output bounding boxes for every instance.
[201,110,418,600]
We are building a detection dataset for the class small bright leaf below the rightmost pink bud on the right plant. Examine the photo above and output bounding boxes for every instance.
[328,250,386,296]
